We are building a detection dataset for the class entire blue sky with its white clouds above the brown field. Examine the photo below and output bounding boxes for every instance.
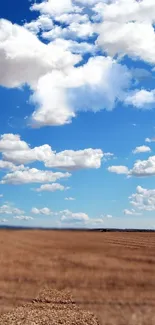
[0,0,155,228]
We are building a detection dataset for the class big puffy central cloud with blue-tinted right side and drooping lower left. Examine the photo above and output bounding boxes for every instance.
[32,56,131,126]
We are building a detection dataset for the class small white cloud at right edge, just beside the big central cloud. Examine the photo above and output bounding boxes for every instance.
[125,89,155,108]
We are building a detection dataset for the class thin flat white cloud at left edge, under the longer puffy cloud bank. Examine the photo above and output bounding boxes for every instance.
[0,168,71,185]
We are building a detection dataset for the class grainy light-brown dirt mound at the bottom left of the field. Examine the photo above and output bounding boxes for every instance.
[0,288,99,325]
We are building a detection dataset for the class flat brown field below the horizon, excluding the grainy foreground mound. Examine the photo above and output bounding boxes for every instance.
[0,230,155,325]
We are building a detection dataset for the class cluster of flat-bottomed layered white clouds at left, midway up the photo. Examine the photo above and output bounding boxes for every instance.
[0,133,108,186]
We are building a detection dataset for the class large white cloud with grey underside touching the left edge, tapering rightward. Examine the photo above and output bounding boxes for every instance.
[0,19,80,89]
